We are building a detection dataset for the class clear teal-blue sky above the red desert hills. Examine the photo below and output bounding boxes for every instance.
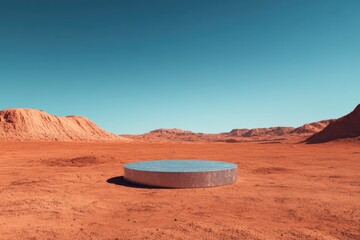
[0,0,360,133]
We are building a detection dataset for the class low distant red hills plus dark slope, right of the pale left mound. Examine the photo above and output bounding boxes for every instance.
[124,104,360,143]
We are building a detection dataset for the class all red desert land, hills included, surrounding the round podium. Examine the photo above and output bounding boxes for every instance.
[0,105,360,240]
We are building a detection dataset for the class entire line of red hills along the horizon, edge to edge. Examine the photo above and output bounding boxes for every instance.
[0,104,360,143]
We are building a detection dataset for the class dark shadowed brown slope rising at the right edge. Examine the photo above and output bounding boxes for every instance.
[306,104,360,143]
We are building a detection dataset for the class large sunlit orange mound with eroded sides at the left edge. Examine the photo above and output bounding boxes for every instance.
[0,109,126,141]
